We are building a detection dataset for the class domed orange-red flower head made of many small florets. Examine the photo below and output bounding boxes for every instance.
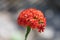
[17,8,46,32]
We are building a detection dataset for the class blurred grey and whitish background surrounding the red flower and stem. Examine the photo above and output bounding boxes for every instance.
[0,0,60,40]
